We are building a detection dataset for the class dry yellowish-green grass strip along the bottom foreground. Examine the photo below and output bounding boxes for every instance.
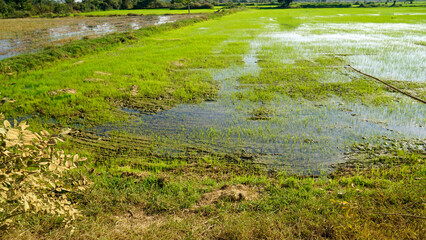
[5,143,426,239]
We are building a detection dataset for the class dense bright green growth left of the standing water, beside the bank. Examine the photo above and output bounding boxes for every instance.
[2,9,245,124]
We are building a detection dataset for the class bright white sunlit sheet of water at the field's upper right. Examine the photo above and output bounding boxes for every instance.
[265,23,426,82]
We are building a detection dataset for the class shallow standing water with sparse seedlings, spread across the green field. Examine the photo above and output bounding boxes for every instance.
[97,13,426,174]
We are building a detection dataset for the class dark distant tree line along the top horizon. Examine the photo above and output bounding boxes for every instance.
[0,0,414,18]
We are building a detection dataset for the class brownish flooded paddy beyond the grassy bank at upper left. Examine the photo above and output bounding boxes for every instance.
[0,15,197,60]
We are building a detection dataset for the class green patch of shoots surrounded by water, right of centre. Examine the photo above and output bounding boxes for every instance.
[237,56,400,105]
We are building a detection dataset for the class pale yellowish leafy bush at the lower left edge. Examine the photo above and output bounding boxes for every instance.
[0,114,88,229]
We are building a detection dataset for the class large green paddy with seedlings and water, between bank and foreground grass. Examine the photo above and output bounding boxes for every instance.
[2,8,426,174]
